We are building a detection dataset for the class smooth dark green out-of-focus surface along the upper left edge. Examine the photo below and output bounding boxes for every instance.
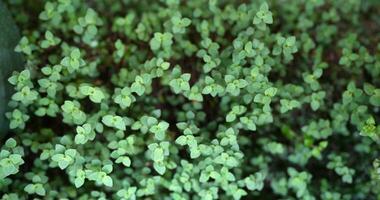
[0,1,23,139]
